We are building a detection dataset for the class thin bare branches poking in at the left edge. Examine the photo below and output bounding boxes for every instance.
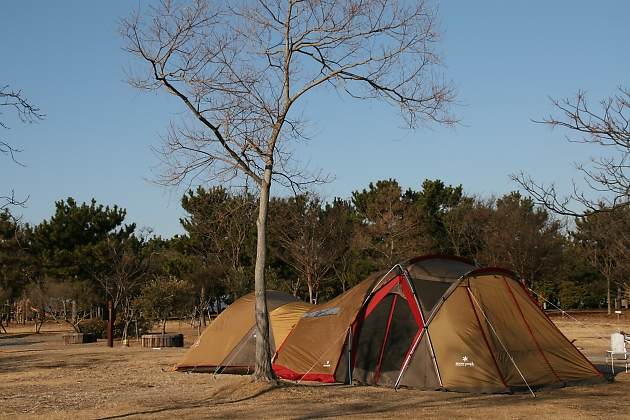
[0,85,44,211]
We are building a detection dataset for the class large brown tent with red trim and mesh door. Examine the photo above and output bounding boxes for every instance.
[273,255,603,392]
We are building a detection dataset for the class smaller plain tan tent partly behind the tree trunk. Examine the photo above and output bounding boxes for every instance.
[173,290,313,373]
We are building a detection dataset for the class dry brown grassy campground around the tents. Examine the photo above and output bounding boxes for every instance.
[0,312,630,420]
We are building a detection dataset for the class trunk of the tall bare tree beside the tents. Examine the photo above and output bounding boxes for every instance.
[254,164,276,381]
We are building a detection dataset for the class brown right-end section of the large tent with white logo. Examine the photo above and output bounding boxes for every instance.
[422,269,603,392]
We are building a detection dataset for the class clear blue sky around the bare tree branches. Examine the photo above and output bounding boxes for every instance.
[0,0,630,237]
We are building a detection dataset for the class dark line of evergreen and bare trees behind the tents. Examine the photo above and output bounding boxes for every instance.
[0,179,630,336]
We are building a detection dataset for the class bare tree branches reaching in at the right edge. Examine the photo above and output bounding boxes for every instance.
[510,87,630,216]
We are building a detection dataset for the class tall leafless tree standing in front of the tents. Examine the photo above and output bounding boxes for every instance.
[119,0,457,380]
